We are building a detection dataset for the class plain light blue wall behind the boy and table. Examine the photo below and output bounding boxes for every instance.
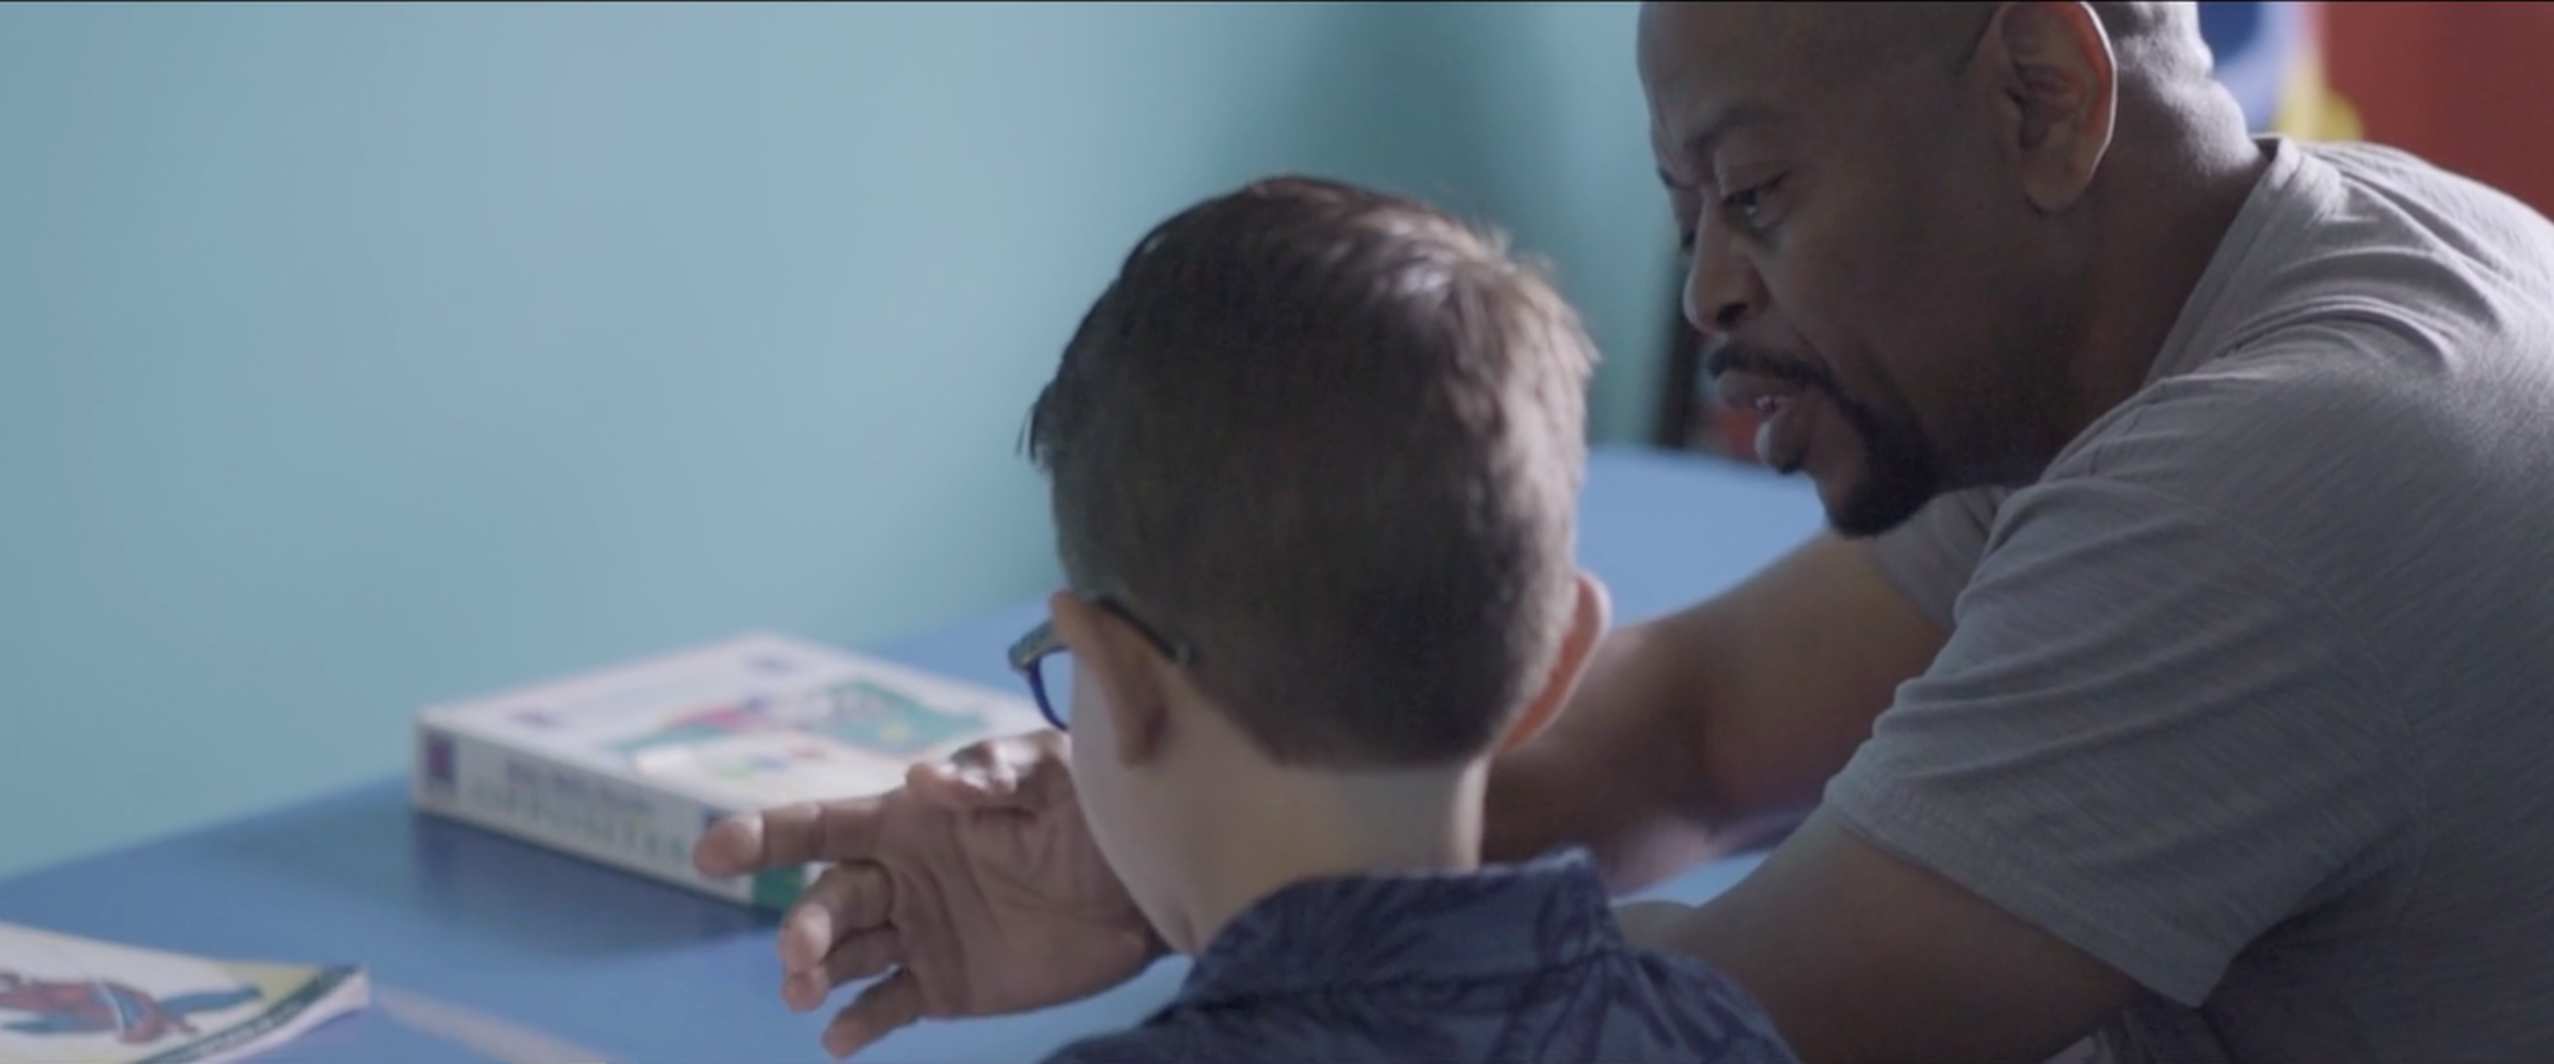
[0,5,1670,873]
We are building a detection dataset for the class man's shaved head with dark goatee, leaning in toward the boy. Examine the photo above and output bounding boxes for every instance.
[1640,3,2242,533]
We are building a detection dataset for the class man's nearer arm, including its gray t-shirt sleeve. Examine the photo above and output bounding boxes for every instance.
[1637,459,2419,1064]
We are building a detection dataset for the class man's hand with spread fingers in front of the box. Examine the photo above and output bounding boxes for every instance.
[692,732,1162,1056]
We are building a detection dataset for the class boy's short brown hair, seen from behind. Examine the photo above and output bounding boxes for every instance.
[1027,176,1594,768]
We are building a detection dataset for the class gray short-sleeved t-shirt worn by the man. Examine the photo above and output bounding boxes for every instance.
[1826,140,2554,1064]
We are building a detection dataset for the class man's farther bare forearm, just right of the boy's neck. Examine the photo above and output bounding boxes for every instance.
[1484,533,1944,888]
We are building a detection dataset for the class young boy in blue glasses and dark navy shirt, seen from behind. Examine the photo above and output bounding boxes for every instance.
[1014,179,1790,1064]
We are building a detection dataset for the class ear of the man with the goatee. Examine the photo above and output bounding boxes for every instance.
[1977,0,2120,214]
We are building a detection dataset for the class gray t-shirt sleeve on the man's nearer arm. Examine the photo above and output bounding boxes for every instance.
[1826,477,2408,1005]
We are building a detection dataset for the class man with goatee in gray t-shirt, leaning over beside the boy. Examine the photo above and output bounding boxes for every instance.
[700,3,2554,1061]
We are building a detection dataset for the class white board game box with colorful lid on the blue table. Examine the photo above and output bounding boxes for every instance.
[411,633,1045,908]
